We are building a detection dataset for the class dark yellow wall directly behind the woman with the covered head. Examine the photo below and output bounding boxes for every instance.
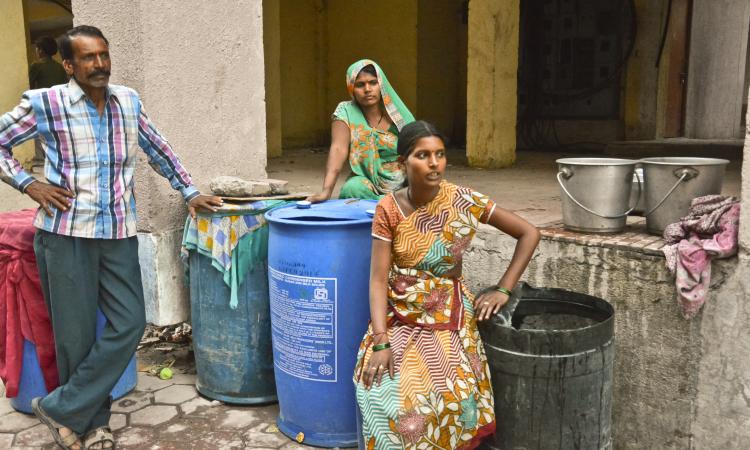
[280,0,424,148]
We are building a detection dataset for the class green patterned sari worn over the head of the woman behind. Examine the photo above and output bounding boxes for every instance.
[333,59,414,199]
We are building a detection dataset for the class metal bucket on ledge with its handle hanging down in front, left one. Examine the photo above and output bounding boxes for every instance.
[556,158,641,233]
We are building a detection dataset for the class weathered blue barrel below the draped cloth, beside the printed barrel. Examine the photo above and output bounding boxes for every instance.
[190,251,276,405]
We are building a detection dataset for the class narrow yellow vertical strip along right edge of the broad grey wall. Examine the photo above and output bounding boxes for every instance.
[263,0,281,158]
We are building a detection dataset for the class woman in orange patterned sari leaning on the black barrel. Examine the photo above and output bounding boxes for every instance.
[354,121,540,449]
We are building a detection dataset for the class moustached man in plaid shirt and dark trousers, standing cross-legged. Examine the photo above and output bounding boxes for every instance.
[0,26,222,449]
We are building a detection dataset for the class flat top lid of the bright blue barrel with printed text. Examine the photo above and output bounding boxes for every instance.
[266,198,378,226]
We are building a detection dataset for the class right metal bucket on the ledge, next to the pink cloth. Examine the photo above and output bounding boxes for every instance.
[641,157,729,234]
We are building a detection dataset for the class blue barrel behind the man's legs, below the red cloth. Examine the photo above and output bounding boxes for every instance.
[10,310,138,414]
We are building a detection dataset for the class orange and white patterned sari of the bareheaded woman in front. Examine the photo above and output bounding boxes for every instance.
[354,181,495,450]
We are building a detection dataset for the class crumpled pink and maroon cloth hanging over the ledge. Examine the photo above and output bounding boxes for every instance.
[663,195,740,319]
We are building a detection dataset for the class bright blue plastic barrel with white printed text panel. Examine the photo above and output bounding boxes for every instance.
[266,199,376,447]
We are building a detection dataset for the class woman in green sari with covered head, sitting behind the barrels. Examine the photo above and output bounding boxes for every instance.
[308,59,414,203]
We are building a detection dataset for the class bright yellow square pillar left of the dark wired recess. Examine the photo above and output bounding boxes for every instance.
[466,0,520,168]
